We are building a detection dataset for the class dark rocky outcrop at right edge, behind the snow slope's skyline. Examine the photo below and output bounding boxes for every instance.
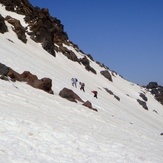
[146,82,163,105]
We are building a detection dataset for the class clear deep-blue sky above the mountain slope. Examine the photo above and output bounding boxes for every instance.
[29,0,163,86]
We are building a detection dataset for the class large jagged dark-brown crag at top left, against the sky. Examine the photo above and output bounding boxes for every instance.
[0,0,68,56]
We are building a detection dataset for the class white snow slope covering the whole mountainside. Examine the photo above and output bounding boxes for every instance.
[0,5,163,163]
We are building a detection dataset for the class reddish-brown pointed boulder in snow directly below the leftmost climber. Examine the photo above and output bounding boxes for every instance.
[59,88,83,102]
